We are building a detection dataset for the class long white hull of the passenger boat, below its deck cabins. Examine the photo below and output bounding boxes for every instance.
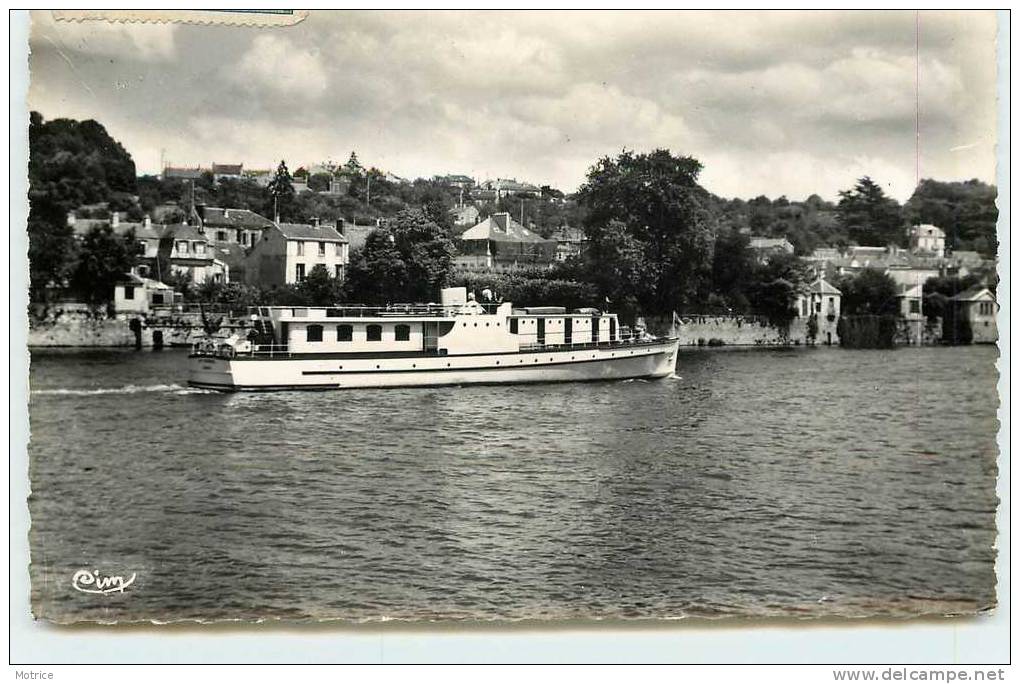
[188,339,678,391]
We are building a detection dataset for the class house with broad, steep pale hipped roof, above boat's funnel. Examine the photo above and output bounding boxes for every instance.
[454,212,556,271]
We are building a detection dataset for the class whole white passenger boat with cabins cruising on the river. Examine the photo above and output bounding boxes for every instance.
[188,287,678,391]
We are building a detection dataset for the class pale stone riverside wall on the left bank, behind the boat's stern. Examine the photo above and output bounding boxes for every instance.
[29,305,247,348]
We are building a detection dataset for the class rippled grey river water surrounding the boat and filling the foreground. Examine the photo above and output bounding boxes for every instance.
[30,348,998,622]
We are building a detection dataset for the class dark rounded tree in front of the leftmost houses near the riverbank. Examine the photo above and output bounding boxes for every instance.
[70,225,139,306]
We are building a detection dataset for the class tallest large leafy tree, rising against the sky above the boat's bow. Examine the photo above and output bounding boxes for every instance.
[578,150,714,314]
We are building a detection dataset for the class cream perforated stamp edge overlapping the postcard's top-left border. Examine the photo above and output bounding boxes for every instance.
[51,9,308,28]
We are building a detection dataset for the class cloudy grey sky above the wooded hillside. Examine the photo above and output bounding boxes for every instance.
[29,10,997,202]
